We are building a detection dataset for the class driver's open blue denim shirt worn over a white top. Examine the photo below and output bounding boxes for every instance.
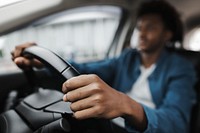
[72,49,196,133]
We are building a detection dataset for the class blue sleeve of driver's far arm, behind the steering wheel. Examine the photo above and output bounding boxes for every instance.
[70,49,134,85]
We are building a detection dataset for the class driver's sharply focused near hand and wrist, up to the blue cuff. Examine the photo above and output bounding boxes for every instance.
[62,74,147,131]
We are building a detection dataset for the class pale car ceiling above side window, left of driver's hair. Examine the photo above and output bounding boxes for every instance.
[0,0,139,34]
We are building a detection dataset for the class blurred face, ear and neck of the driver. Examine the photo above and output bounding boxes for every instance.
[137,14,172,67]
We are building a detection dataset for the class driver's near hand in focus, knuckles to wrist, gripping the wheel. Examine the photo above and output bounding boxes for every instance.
[62,74,124,119]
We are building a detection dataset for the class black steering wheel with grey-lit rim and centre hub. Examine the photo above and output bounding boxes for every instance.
[0,46,79,133]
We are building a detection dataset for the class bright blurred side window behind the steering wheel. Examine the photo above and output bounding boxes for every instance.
[0,6,121,62]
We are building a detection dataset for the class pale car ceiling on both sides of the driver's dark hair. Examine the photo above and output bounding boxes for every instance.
[0,0,200,34]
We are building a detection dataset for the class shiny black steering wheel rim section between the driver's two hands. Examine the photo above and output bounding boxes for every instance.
[22,46,79,80]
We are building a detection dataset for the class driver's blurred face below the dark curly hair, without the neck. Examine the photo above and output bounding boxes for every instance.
[136,14,169,53]
